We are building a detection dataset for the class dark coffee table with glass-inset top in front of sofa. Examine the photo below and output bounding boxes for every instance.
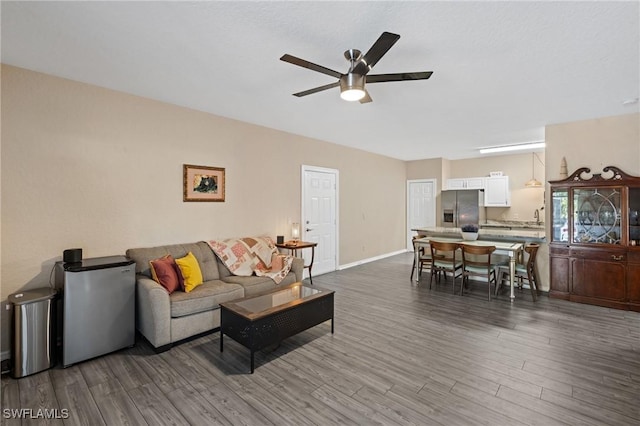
[220,283,334,373]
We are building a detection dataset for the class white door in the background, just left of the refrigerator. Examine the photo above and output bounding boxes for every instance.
[407,179,436,251]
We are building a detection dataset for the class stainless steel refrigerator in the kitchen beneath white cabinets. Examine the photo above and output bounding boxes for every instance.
[441,189,486,228]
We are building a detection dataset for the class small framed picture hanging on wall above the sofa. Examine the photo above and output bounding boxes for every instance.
[182,164,226,202]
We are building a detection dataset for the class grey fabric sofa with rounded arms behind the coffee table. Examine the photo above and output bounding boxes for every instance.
[126,241,304,352]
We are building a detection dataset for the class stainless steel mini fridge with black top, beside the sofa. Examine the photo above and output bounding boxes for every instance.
[55,256,135,367]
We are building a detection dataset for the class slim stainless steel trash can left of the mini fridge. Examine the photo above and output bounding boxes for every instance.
[9,287,56,378]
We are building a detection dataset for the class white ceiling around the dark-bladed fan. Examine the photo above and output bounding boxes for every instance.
[1,1,640,160]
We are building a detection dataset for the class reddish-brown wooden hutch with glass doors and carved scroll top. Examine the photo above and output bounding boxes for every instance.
[549,166,640,311]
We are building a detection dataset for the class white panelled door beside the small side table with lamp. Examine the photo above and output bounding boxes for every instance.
[300,166,338,276]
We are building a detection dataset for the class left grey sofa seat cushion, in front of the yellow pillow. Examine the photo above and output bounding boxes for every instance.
[169,280,244,318]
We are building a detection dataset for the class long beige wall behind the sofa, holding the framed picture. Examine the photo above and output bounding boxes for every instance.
[0,66,406,350]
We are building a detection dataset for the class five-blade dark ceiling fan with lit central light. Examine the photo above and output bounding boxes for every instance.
[280,31,433,104]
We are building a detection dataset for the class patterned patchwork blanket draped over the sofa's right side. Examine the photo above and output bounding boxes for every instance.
[207,237,293,284]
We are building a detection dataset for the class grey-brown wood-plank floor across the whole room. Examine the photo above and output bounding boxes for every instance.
[2,254,640,425]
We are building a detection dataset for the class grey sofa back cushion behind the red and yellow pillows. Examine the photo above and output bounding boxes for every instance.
[127,241,220,281]
